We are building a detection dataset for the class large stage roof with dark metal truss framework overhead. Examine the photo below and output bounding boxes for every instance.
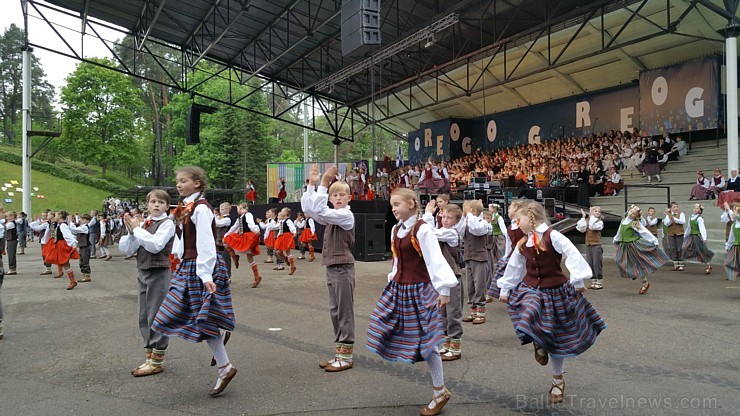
[21,0,738,140]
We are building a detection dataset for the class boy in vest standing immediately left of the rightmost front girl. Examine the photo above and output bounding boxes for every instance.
[463,200,493,324]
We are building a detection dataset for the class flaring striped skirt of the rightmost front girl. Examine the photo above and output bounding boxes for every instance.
[508,283,606,358]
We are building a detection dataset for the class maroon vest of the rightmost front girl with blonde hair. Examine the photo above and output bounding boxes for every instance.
[522,228,568,289]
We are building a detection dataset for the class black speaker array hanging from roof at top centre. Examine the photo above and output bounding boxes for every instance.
[342,0,380,55]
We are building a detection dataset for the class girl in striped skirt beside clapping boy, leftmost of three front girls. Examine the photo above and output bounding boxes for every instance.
[152,166,236,396]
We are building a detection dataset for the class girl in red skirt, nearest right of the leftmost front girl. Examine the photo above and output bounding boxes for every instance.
[224,202,262,288]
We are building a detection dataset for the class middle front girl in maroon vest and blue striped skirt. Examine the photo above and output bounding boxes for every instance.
[367,188,458,415]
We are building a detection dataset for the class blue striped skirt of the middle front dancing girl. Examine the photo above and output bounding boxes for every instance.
[367,281,444,363]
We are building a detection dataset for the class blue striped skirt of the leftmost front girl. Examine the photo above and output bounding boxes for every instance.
[152,253,235,342]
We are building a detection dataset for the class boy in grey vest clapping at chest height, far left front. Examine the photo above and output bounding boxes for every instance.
[119,189,175,377]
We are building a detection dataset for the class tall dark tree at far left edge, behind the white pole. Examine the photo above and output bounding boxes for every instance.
[0,24,54,145]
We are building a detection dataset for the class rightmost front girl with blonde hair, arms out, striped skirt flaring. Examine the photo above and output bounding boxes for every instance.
[498,201,606,403]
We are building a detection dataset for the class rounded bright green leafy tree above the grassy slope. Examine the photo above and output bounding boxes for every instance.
[58,58,151,177]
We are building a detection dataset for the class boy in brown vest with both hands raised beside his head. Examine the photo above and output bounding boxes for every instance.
[301,164,355,373]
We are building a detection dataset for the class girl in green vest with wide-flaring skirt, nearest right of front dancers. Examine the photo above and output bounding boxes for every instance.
[613,205,670,295]
